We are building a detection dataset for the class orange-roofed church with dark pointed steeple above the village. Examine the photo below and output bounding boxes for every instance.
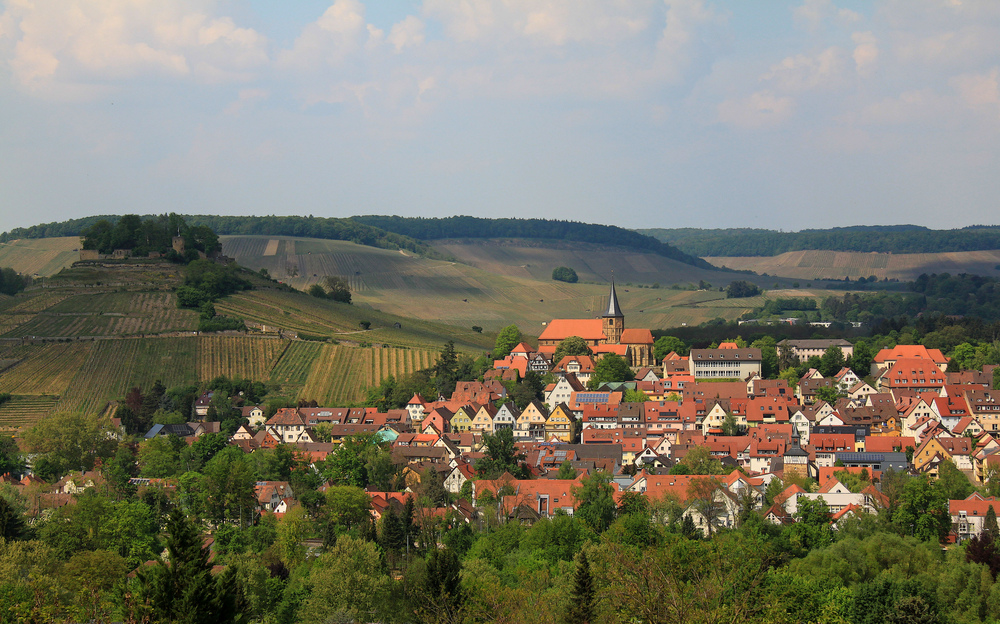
[538,282,655,367]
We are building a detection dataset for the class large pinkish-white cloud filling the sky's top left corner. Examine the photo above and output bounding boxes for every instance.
[0,0,267,96]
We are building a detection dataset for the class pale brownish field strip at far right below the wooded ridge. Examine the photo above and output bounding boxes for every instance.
[705,250,1000,280]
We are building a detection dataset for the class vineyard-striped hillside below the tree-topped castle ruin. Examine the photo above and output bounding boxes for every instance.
[0,263,495,427]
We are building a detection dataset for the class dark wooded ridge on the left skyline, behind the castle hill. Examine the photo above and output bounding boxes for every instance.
[0,215,437,257]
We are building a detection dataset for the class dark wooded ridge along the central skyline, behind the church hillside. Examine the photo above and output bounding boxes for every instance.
[352,215,719,270]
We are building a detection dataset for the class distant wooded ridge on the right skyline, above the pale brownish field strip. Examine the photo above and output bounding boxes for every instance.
[638,225,1000,257]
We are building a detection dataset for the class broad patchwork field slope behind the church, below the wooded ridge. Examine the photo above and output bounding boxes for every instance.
[222,236,780,336]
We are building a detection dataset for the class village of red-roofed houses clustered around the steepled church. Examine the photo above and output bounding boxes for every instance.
[4,286,1000,542]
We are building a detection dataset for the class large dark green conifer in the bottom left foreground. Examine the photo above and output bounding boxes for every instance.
[136,509,237,624]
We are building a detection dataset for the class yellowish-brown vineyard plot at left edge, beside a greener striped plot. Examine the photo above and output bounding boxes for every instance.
[0,342,94,395]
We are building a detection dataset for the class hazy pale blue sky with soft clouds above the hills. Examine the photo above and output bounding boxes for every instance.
[0,0,1000,231]
